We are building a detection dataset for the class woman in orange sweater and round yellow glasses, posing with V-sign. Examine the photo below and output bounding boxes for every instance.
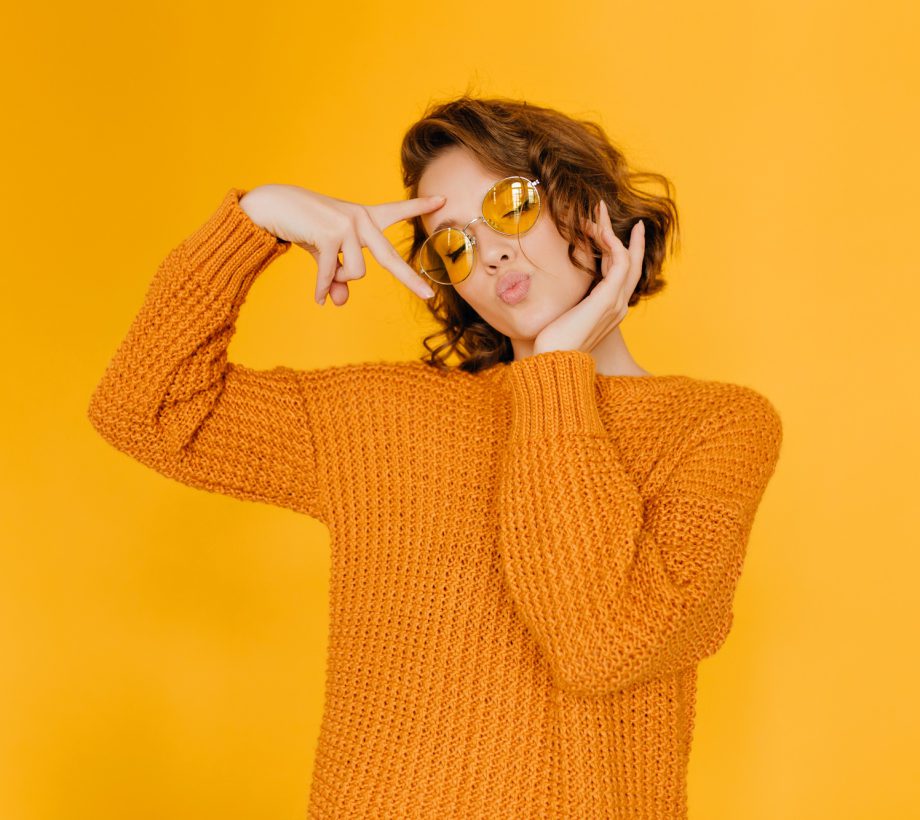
[89,95,782,819]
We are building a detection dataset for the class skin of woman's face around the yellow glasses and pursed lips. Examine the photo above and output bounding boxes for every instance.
[418,145,593,344]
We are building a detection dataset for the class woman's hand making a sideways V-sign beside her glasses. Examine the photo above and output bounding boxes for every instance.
[240,184,444,305]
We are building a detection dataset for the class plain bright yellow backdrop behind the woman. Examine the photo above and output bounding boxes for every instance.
[0,0,920,820]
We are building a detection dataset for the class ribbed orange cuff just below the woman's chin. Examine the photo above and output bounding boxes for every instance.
[506,350,607,439]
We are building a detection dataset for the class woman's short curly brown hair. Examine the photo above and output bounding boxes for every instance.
[400,92,680,373]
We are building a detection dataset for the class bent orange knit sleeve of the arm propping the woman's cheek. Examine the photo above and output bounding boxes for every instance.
[498,351,782,695]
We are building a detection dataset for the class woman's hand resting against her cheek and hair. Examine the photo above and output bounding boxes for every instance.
[533,200,645,355]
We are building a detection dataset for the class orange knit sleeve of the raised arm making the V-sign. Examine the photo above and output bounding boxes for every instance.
[82,188,325,520]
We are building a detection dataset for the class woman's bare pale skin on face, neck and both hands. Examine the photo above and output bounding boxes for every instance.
[240,146,652,376]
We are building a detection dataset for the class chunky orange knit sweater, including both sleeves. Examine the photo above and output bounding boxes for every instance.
[89,188,782,820]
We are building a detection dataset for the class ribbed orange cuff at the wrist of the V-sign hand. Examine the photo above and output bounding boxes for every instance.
[184,188,291,297]
